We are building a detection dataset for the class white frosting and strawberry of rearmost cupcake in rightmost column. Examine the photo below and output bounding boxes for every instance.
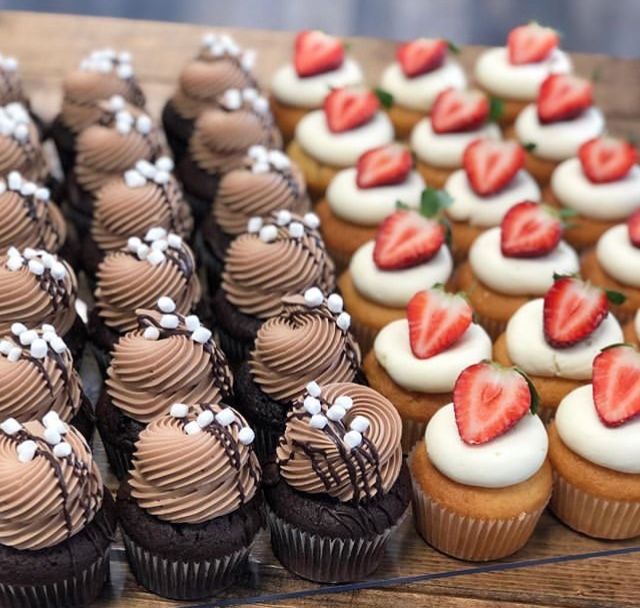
[475,23,573,101]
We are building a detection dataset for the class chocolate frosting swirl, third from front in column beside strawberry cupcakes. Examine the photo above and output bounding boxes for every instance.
[222,211,335,319]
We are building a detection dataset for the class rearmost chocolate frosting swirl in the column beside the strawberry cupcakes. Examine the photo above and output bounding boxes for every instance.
[171,32,256,120]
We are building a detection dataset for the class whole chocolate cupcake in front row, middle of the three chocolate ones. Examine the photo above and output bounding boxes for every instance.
[117,404,264,600]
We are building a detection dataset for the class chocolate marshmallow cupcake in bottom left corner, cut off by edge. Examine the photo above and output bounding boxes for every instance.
[0,411,116,608]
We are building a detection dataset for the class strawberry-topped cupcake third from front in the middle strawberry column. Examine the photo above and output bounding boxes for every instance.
[456,201,584,340]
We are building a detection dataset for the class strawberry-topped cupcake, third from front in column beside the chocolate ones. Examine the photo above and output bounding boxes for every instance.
[338,209,453,355]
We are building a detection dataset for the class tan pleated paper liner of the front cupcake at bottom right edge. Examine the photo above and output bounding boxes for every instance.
[549,470,640,540]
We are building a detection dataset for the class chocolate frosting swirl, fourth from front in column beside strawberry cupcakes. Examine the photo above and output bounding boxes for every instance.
[212,145,311,236]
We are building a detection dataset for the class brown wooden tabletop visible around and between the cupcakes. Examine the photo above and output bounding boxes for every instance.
[0,12,640,608]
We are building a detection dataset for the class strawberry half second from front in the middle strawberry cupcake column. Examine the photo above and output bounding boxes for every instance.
[543,277,609,348]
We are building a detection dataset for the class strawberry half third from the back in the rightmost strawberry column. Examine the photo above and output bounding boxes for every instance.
[578,137,638,184]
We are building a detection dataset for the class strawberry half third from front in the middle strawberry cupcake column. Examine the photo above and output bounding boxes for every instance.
[500,201,562,258]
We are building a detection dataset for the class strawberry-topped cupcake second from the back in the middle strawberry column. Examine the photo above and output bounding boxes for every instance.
[411,88,502,188]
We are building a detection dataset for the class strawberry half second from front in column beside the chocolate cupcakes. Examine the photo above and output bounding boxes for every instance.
[407,287,473,359]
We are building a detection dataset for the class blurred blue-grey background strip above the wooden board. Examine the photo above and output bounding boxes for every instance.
[0,0,640,57]
